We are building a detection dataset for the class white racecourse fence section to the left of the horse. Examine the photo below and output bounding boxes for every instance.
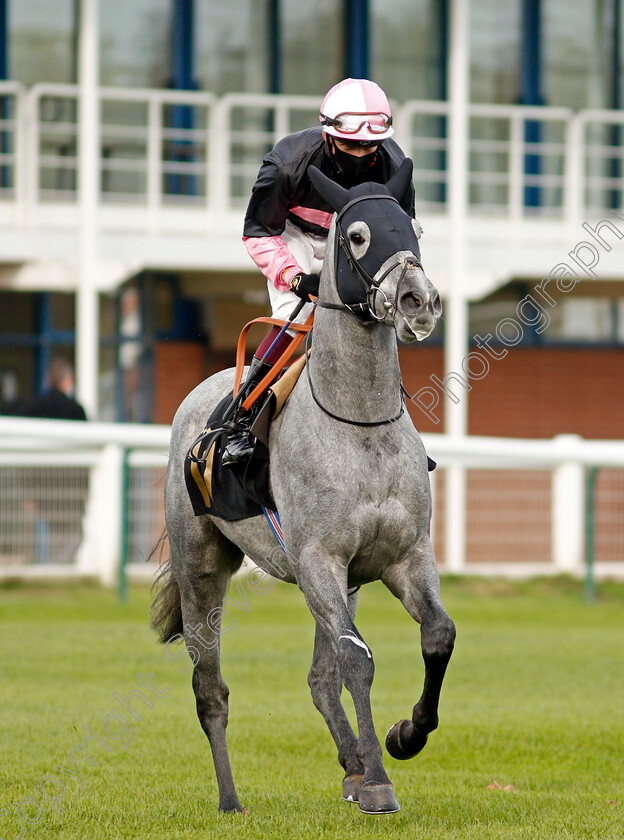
[0,418,170,585]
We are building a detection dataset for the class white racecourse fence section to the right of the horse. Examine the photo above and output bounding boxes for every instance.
[422,434,624,577]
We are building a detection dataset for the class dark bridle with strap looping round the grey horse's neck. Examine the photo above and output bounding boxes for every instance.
[305,195,422,427]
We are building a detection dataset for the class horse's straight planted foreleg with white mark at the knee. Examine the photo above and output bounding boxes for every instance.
[297,549,399,813]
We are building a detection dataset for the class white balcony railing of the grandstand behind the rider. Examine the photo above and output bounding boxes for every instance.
[0,82,624,233]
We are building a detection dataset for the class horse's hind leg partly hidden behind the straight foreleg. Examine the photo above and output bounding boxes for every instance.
[308,592,364,802]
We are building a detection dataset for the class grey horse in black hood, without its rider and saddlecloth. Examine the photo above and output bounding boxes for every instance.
[152,161,455,814]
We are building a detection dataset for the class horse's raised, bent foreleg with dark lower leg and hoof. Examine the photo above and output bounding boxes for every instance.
[382,539,455,759]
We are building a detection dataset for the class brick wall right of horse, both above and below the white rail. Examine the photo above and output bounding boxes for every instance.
[400,346,624,565]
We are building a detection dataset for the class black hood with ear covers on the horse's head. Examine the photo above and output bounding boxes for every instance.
[308,158,420,305]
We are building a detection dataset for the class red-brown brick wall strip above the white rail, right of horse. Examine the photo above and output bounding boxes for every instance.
[400,346,624,439]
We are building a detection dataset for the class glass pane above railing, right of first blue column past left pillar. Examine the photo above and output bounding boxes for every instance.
[195,0,269,95]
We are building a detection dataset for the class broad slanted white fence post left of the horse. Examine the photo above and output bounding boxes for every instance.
[77,443,124,586]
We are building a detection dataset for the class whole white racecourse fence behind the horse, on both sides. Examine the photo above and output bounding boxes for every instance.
[0,418,624,585]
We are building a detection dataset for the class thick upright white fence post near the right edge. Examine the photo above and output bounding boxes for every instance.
[551,435,585,574]
